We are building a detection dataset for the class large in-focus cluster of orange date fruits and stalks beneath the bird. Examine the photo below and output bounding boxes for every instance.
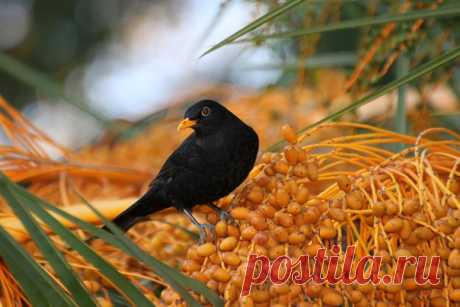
[162,123,460,306]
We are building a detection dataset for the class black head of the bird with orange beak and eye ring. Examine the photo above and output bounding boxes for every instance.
[177,100,234,135]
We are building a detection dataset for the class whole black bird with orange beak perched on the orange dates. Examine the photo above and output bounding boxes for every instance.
[104,100,259,242]
